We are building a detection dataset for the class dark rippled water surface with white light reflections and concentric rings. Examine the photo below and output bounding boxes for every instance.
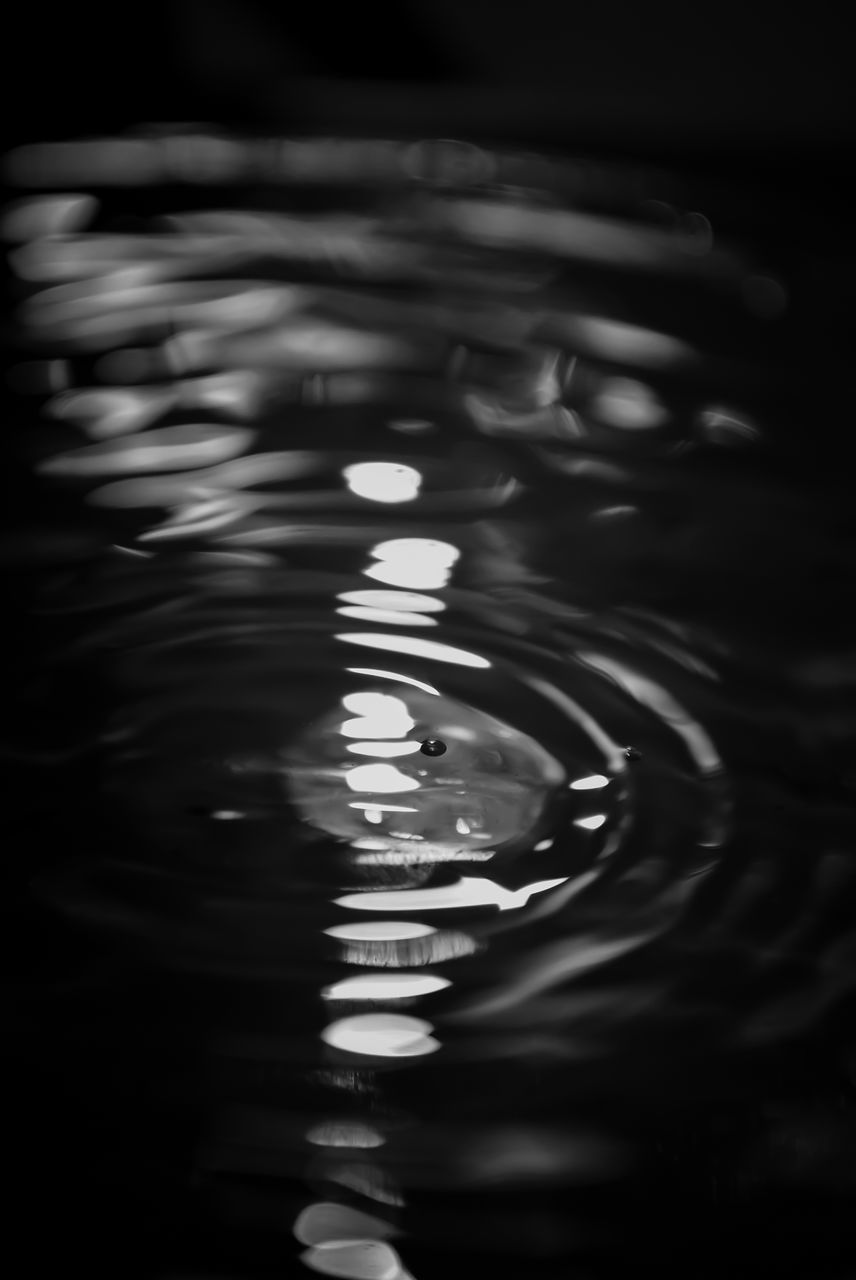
[3,132,856,1280]
